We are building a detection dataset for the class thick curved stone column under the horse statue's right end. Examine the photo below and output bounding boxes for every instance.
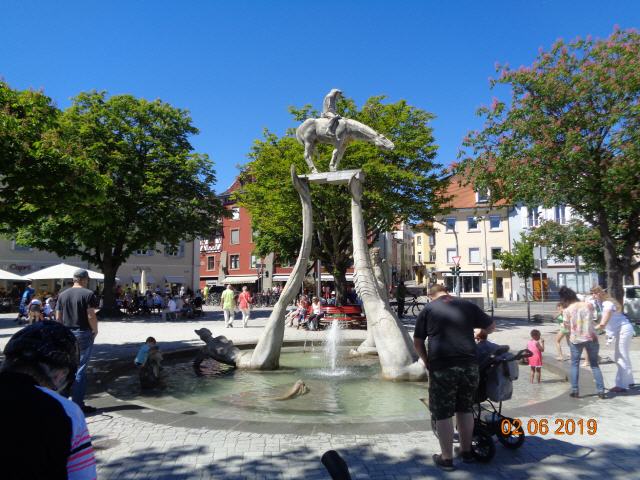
[349,172,427,380]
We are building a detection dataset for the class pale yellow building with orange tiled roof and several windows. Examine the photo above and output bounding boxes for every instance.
[434,177,512,305]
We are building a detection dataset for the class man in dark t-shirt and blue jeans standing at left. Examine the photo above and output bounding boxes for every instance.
[56,268,98,413]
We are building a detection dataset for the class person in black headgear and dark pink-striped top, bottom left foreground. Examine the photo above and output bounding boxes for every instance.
[0,320,96,480]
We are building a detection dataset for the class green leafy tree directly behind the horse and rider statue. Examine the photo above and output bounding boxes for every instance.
[238,97,444,302]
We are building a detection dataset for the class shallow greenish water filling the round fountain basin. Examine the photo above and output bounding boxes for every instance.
[96,345,567,433]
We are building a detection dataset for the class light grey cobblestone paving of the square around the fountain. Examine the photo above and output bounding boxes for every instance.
[0,311,640,479]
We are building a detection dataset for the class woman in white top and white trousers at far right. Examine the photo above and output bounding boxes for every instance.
[591,286,634,392]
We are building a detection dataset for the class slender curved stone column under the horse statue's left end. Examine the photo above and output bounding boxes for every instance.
[236,165,313,370]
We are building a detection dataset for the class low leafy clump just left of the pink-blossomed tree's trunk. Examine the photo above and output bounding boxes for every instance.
[529,219,605,272]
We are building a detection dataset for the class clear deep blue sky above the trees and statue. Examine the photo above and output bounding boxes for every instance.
[0,0,640,191]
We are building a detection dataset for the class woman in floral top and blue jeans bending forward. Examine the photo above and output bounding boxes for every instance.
[558,287,605,398]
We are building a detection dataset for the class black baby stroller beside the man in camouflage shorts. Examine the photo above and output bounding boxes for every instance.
[431,342,532,463]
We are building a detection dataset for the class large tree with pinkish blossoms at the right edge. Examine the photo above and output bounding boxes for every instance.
[461,30,640,300]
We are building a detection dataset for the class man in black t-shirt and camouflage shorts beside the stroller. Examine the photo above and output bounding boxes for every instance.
[413,285,495,470]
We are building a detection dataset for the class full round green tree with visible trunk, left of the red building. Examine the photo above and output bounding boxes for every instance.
[13,92,223,315]
